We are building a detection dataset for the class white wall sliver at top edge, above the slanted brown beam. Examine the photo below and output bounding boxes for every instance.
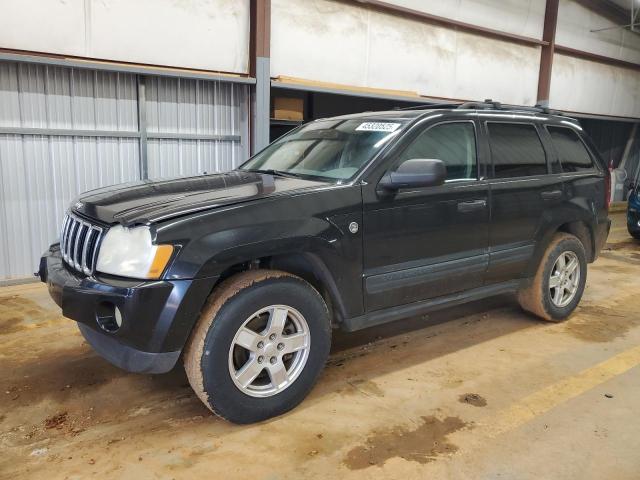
[386,0,546,38]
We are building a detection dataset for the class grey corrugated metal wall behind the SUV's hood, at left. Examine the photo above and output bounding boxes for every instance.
[0,62,248,281]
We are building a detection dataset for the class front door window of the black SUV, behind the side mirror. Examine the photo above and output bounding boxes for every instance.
[400,122,478,180]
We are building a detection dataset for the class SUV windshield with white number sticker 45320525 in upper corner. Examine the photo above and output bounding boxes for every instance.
[240,119,405,181]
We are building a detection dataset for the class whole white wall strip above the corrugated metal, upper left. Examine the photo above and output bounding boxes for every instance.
[0,0,249,73]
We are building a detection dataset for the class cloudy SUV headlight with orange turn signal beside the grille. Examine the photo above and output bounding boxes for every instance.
[96,225,173,279]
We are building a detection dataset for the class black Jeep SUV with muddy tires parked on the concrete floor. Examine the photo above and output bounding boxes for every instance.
[39,102,610,423]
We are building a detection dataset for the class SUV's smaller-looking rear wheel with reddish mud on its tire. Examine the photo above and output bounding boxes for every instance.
[518,233,587,322]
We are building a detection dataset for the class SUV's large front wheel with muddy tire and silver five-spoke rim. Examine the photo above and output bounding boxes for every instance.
[184,270,331,424]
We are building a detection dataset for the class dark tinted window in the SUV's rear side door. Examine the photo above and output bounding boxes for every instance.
[487,123,547,178]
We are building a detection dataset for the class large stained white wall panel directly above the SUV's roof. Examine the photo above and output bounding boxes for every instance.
[271,0,540,104]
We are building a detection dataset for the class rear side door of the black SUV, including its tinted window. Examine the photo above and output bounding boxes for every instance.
[483,118,565,284]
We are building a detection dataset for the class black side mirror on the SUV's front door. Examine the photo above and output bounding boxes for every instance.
[378,158,447,191]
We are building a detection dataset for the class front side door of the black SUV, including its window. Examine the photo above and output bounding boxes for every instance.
[363,120,489,312]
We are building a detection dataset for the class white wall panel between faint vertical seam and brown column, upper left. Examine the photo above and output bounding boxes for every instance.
[90,0,249,73]
